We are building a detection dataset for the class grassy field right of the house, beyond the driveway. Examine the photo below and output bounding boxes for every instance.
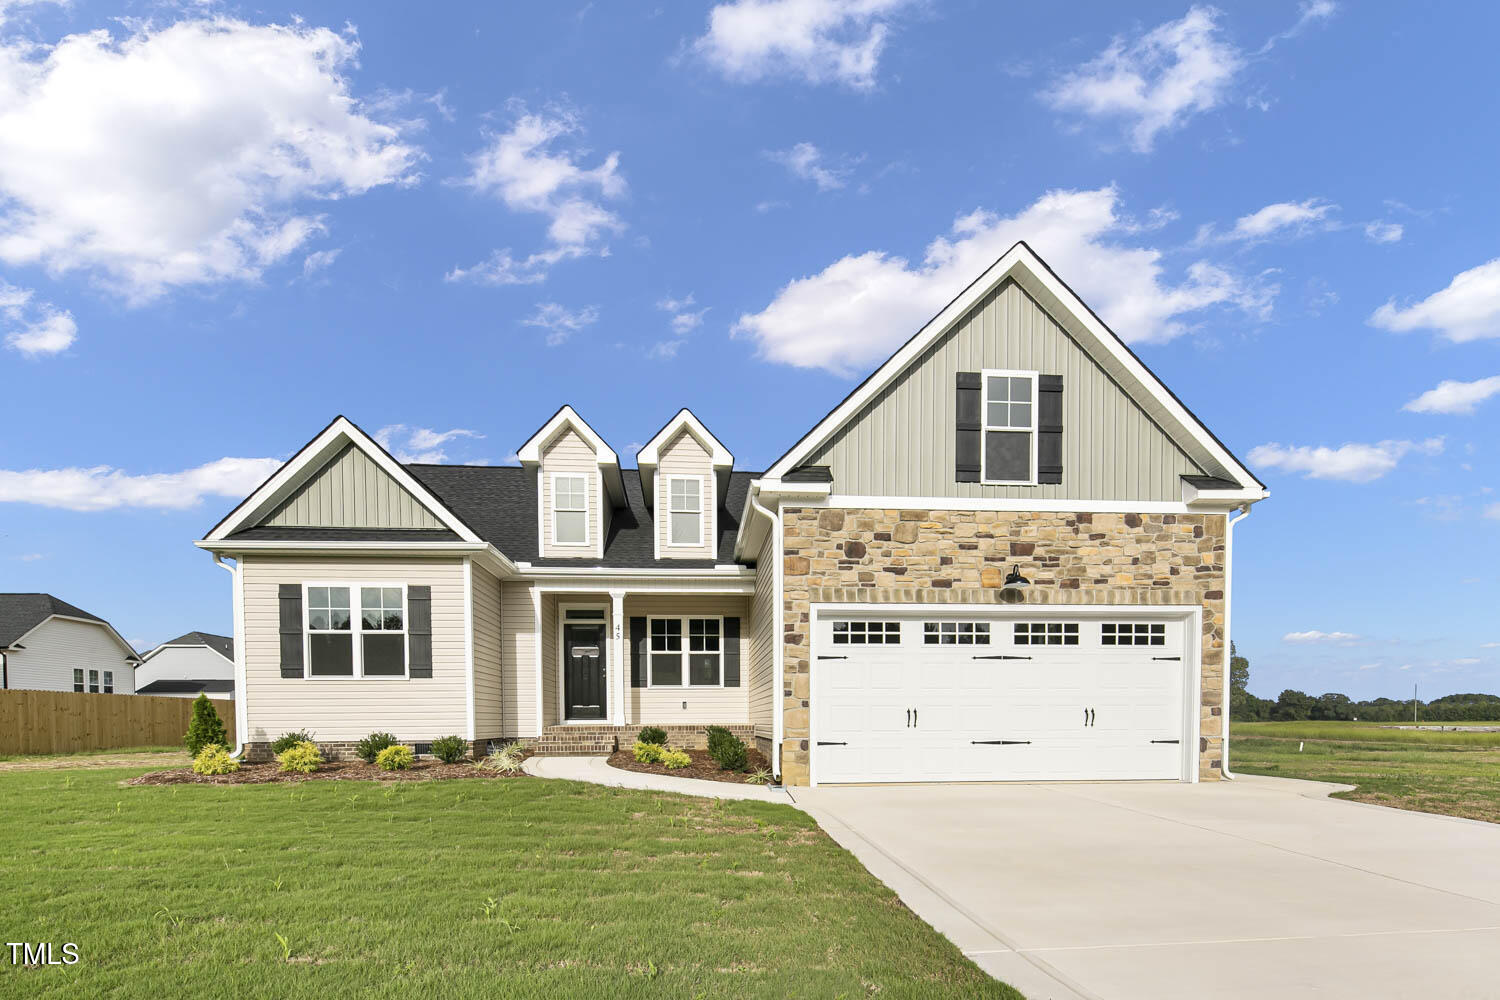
[1230,723,1500,823]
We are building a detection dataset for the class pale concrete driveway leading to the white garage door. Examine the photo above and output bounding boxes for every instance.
[792,777,1500,1000]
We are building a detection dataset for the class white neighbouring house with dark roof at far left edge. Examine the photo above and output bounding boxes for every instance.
[0,594,141,694]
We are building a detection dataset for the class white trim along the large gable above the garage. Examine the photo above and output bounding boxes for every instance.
[765,243,1269,499]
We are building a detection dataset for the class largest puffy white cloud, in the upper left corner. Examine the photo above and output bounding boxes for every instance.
[0,18,420,301]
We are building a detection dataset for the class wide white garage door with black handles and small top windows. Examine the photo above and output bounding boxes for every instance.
[812,607,1190,783]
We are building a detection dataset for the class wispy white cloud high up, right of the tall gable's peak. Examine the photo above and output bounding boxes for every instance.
[1041,7,1245,153]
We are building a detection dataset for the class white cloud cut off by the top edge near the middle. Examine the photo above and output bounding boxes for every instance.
[692,0,915,90]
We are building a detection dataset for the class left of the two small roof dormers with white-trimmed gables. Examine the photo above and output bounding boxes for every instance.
[516,406,626,559]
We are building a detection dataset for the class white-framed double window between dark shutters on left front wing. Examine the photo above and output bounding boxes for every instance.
[306,583,407,678]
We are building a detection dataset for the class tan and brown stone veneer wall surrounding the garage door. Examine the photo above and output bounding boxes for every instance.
[782,507,1226,784]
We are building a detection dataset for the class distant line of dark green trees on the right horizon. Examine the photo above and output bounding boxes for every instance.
[1229,643,1500,723]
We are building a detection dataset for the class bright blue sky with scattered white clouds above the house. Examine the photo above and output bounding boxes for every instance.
[0,0,1500,697]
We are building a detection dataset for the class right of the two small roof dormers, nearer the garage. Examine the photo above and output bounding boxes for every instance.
[636,409,735,559]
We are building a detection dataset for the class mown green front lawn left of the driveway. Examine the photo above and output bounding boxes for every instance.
[0,768,1019,1000]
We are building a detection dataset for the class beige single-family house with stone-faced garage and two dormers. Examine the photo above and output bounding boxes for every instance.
[197,243,1268,784]
